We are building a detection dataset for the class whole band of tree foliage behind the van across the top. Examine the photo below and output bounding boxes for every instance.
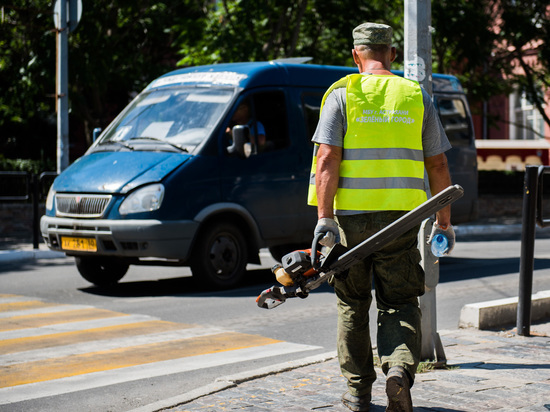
[0,0,550,169]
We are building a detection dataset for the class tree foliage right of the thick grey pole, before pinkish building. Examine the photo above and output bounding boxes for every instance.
[432,0,550,134]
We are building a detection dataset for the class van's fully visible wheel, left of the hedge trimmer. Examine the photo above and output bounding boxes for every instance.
[190,222,248,289]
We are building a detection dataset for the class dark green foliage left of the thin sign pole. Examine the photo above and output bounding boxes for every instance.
[0,0,56,166]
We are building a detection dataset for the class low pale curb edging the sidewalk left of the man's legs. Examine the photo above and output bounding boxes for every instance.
[128,351,337,412]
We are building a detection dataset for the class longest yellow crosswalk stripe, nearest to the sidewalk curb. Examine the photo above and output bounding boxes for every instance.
[0,332,281,388]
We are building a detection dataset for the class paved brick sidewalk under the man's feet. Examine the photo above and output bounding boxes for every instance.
[137,324,550,412]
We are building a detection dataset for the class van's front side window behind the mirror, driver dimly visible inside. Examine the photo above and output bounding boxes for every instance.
[252,91,290,153]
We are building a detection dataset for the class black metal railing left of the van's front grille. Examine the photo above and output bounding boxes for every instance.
[0,172,57,249]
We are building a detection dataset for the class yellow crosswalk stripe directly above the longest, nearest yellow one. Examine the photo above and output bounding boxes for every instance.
[0,321,193,355]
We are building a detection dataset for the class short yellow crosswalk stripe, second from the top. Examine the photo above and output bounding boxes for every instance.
[0,308,128,332]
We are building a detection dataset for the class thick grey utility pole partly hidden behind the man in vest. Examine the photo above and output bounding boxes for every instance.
[405,0,447,364]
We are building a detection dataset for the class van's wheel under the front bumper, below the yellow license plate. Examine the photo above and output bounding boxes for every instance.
[75,257,130,287]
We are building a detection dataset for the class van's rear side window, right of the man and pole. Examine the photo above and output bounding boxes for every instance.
[436,97,472,145]
